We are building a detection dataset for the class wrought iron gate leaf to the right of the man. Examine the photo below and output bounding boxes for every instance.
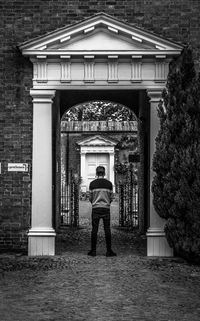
[119,165,138,228]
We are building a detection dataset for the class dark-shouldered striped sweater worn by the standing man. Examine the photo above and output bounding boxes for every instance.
[89,178,113,208]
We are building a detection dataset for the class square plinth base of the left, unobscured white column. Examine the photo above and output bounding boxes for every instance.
[28,228,56,256]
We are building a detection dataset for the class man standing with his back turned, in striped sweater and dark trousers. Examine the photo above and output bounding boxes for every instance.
[88,166,116,256]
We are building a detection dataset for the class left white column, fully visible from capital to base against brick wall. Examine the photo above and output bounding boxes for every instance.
[28,90,56,256]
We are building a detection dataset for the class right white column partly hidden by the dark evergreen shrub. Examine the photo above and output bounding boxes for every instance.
[147,90,173,256]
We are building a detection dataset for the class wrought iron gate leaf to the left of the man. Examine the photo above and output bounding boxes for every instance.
[61,171,79,227]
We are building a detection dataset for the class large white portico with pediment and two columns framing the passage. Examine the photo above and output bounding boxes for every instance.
[20,13,182,256]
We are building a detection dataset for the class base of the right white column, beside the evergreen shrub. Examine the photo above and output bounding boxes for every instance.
[146,228,174,257]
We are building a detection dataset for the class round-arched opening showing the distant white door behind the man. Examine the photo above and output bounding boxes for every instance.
[58,101,141,230]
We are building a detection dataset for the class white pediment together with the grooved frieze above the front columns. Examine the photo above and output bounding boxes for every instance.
[20,13,182,88]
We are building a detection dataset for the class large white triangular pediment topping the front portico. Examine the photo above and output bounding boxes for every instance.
[20,13,182,56]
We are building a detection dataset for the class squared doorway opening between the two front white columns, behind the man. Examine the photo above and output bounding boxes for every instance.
[54,91,148,252]
